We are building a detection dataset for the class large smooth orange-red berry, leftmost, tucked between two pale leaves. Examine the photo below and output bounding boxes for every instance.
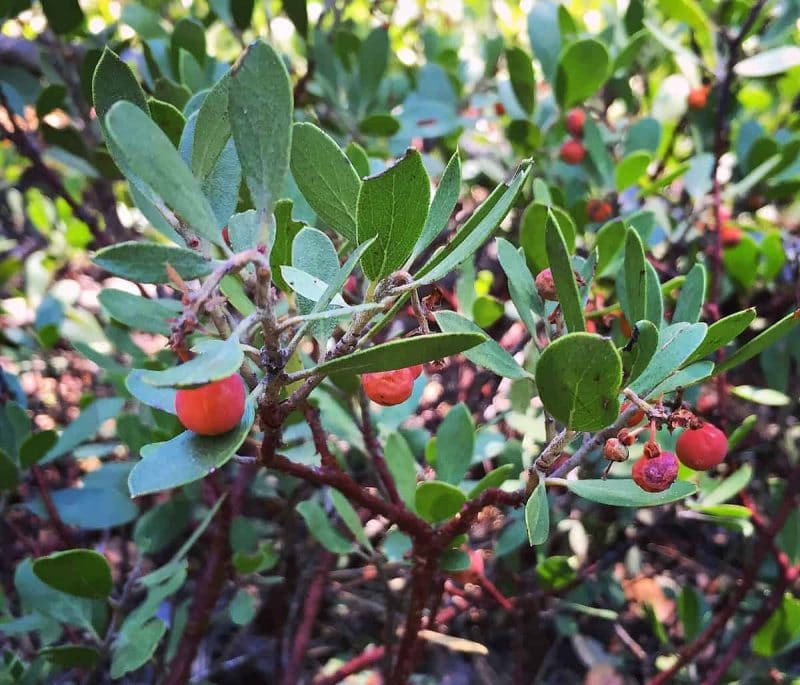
[175,373,247,435]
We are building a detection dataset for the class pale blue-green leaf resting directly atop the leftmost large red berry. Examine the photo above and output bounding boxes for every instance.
[141,338,244,388]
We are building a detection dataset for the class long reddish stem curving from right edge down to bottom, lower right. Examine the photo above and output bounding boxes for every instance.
[647,469,800,685]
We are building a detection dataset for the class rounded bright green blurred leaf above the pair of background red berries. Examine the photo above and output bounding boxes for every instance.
[555,38,611,107]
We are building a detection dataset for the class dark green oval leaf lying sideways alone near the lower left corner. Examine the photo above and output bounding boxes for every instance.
[33,549,114,599]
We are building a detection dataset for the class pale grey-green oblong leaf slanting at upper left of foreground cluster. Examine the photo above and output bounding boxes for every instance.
[105,100,222,245]
